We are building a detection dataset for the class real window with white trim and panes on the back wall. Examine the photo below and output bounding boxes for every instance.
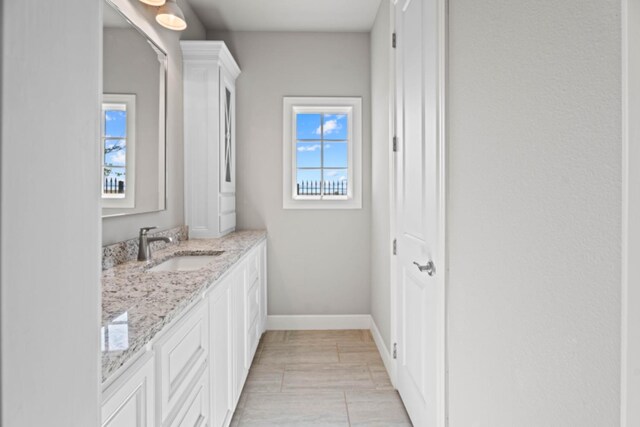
[283,97,362,209]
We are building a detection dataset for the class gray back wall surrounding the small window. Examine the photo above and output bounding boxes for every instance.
[207,32,371,315]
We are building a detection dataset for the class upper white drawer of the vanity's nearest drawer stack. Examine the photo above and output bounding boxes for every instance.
[155,303,209,422]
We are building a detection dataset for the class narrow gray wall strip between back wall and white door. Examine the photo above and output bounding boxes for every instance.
[371,0,392,349]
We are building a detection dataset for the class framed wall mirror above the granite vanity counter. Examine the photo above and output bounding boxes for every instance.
[98,0,167,218]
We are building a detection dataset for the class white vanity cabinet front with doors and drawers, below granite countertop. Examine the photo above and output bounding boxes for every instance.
[102,241,267,427]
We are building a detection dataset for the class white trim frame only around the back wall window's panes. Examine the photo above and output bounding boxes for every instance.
[282,97,362,209]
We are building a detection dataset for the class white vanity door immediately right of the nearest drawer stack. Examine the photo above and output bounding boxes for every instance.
[209,277,233,427]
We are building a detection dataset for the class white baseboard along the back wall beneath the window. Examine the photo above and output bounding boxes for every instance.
[267,314,371,331]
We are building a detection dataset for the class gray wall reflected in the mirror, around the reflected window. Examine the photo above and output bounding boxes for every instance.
[102,28,164,215]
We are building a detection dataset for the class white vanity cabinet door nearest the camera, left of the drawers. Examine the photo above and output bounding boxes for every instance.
[102,354,154,427]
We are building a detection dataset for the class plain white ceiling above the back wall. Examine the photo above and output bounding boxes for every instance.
[189,0,380,32]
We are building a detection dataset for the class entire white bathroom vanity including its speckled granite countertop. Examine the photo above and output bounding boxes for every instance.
[102,231,267,427]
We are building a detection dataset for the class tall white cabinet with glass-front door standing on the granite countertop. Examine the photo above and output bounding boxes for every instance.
[180,41,240,238]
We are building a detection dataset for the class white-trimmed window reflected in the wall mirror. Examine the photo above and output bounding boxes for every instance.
[101,94,136,208]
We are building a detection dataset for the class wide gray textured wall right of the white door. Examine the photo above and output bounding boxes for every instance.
[447,0,621,427]
